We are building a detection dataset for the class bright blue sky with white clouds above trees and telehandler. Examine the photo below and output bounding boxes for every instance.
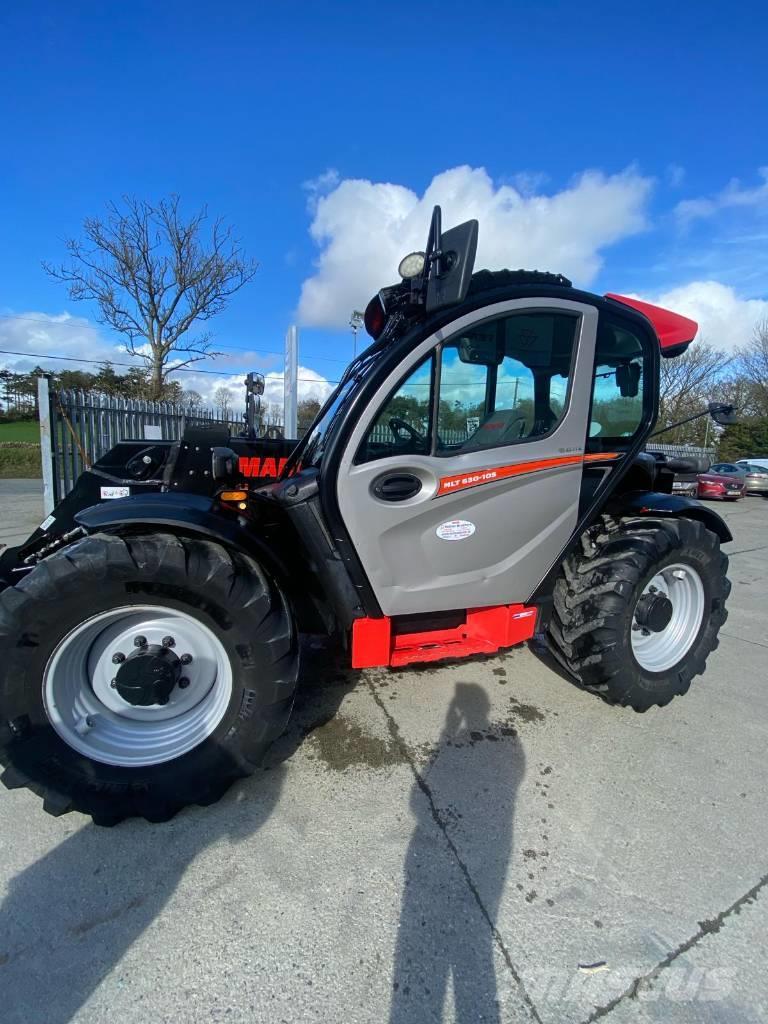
[0,0,768,403]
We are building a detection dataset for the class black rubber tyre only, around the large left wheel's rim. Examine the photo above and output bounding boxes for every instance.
[0,530,298,825]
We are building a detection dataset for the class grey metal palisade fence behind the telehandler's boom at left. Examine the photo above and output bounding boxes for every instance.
[38,377,282,515]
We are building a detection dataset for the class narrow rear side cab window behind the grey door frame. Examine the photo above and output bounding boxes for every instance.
[589,322,643,439]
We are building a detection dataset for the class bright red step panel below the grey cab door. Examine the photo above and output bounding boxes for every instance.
[352,604,538,669]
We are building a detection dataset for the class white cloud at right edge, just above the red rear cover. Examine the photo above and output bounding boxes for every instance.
[648,281,768,352]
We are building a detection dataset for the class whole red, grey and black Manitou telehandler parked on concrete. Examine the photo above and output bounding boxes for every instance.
[0,208,732,824]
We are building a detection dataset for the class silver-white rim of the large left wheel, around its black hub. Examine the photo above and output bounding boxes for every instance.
[43,604,232,767]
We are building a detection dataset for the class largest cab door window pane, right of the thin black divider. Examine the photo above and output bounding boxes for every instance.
[435,312,579,456]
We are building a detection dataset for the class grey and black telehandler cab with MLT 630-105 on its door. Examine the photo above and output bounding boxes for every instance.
[286,208,708,615]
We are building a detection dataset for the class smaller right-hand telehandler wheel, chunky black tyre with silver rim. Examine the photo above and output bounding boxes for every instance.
[548,518,730,712]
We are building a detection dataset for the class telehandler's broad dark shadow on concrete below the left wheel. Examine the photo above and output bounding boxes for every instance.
[0,634,354,1024]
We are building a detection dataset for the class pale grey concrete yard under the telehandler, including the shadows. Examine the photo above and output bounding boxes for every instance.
[0,481,768,1024]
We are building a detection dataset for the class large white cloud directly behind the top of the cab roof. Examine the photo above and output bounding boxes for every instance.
[299,166,652,328]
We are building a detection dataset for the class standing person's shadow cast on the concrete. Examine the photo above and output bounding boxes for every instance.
[389,683,525,1024]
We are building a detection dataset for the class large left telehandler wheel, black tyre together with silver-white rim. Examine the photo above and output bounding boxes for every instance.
[0,534,298,824]
